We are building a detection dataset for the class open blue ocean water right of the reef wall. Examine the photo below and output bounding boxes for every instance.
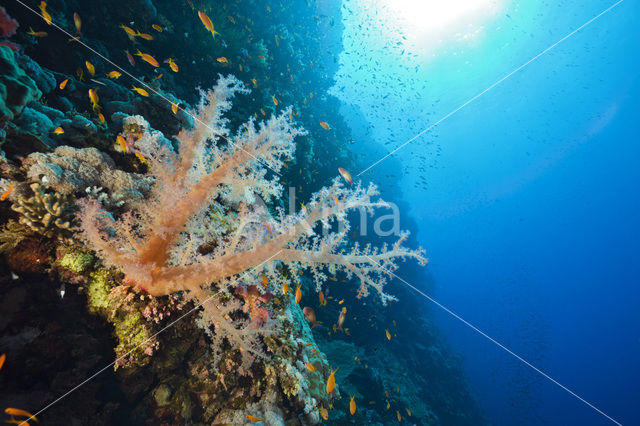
[334,0,640,425]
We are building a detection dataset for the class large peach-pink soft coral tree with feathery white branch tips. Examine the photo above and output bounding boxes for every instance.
[79,76,425,366]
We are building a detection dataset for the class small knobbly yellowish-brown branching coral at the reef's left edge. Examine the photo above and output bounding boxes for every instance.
[11,183,75,239]
